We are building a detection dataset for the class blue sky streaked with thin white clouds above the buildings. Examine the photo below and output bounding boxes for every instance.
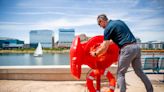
[0,0,164,43]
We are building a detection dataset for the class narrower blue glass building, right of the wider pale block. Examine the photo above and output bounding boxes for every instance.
[58,29,75,47]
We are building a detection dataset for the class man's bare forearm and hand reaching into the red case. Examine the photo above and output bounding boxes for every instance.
[90,40,111,57]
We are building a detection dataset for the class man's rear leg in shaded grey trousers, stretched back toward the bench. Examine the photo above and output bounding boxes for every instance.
[132,46,153,92]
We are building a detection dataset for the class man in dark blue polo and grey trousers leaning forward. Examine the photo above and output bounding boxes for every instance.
[90,14,153,92]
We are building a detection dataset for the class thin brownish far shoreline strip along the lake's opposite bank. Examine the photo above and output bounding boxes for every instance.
[0,49,164,53]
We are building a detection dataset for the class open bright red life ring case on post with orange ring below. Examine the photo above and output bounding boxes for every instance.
[70,36,119,92]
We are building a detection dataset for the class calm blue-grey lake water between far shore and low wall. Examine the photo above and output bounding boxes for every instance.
[0,53,164,66]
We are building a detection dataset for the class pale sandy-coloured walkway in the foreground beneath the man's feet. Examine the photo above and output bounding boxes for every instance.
[0,71,164,92]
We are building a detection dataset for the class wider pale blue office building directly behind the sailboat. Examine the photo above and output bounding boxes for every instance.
[30,30,54,48]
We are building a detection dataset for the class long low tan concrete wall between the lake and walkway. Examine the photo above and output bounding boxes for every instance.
[0,65,117,81]
